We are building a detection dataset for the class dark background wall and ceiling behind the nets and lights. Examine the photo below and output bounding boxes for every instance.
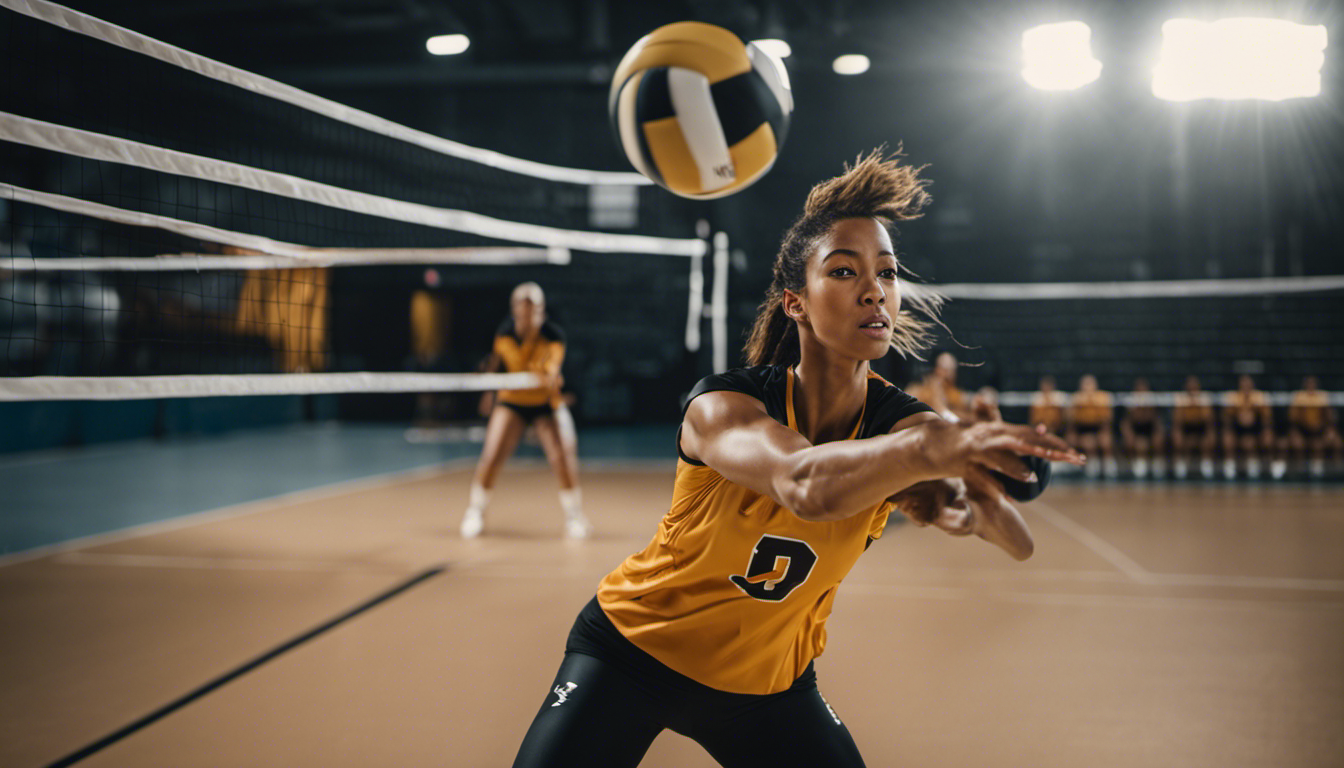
[0,0,1344,451]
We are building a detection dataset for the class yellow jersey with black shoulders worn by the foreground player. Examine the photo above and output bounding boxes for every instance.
[597,366,931,694]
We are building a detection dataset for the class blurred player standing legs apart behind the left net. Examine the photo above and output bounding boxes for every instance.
[461,282,591,538]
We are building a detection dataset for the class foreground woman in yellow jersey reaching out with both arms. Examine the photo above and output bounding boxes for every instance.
[513,152,1082,768]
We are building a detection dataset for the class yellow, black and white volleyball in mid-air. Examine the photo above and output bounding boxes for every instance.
[607,22,793,199]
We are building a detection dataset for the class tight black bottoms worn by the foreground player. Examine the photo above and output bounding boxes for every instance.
[513,599,863,768]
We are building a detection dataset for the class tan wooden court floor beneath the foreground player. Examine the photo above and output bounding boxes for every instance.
[0,461,1344,768]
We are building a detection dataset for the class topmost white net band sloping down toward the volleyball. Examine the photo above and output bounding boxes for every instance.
[0,0,652,186]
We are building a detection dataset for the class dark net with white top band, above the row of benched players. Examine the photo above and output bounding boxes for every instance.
[913,276,1344,418]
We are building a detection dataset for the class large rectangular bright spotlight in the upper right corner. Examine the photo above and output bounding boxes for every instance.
[1153,19,1327,101]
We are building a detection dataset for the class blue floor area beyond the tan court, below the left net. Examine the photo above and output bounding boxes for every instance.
[0,424,676,555]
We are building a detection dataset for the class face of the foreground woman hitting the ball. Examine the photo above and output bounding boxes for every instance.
[801,219,900,360]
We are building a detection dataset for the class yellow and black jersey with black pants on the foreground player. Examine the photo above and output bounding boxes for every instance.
[515,366,930,768]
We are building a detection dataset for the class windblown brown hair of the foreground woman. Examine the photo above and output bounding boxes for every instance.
[745,147,943,366]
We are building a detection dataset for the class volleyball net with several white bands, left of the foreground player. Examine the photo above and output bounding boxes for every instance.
[0,0,727,408]
